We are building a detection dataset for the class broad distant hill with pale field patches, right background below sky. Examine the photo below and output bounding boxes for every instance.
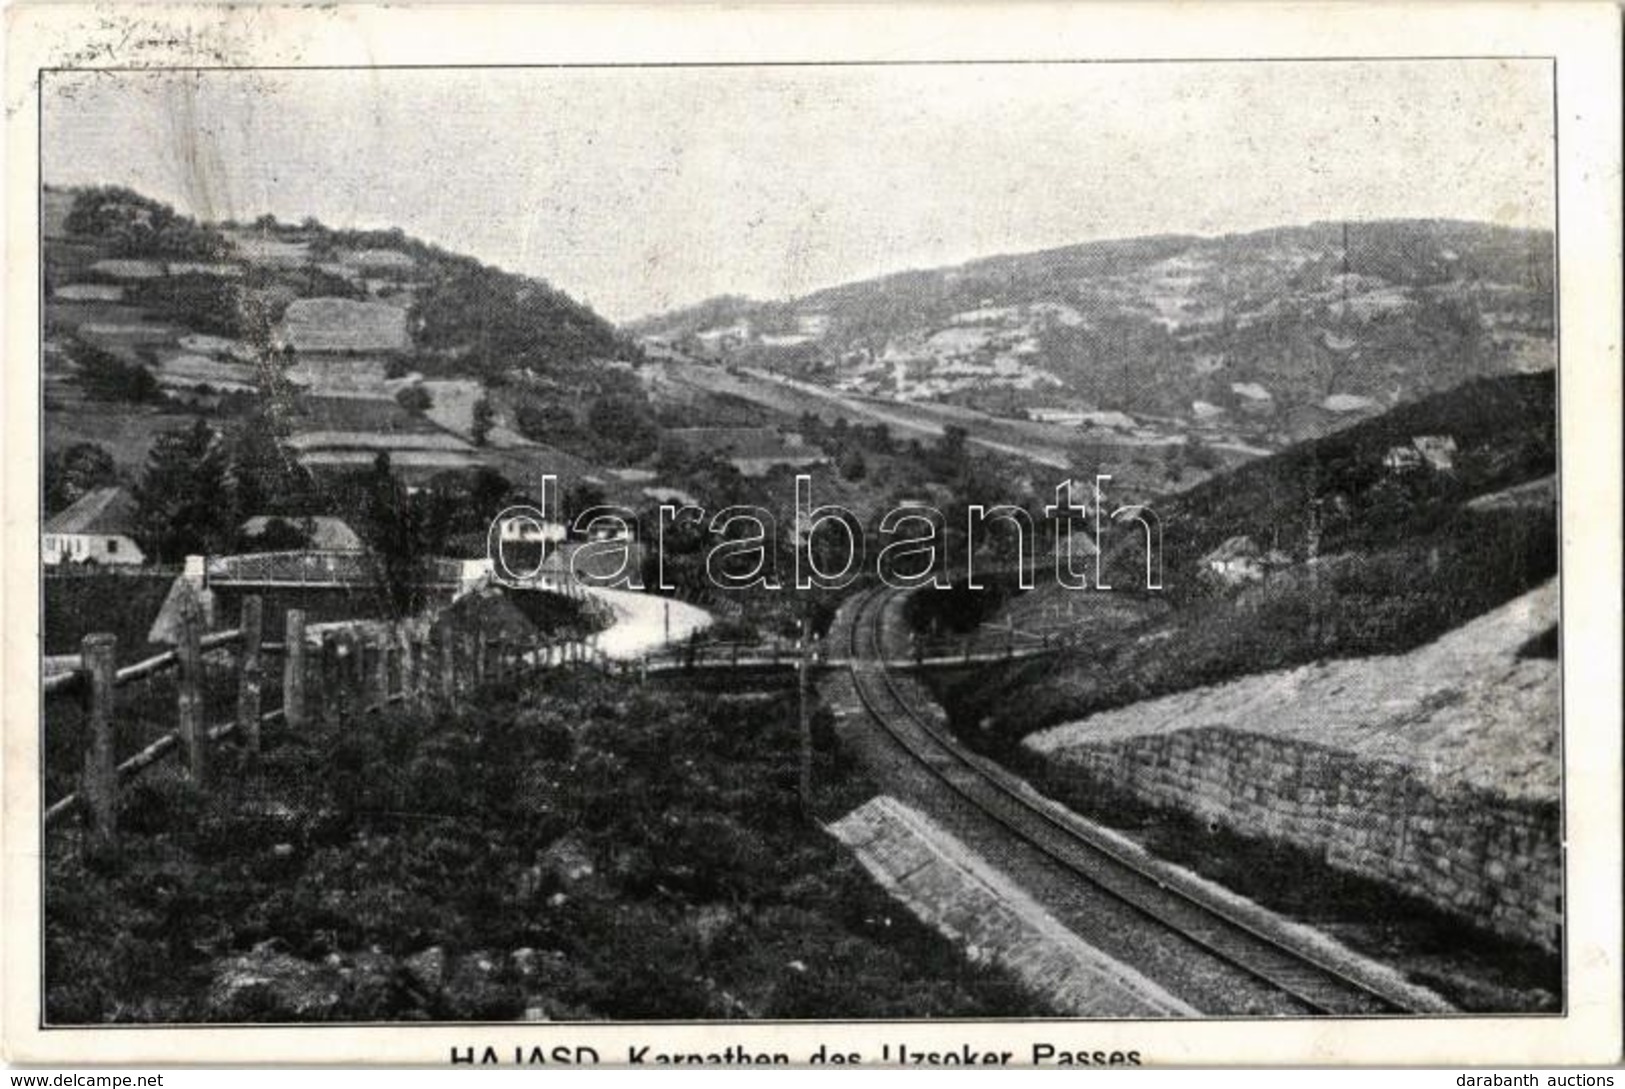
[629,219,1554,447]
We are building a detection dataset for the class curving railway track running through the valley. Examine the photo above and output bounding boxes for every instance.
[839,590,1440,1016]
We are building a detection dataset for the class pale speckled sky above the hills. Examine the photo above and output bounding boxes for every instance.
[42,60,1554,322]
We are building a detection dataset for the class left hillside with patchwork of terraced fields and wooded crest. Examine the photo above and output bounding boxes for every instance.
[42,187,647,494]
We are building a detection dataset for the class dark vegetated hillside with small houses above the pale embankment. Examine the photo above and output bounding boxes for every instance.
[944,374,1557,749]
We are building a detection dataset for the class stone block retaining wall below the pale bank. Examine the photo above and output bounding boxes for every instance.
[1050,727,1563,949]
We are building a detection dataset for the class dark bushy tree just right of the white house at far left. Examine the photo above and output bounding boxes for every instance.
[135,418,232,562]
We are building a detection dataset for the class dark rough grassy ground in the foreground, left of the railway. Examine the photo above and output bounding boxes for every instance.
[46,673,1035,1022]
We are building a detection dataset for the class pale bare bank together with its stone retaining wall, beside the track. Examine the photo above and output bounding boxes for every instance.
[1024,582,1563,951]
